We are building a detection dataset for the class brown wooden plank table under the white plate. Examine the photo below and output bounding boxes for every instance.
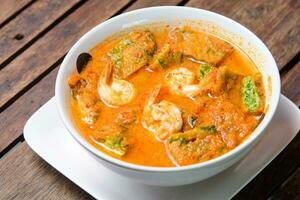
[0,0,300,199]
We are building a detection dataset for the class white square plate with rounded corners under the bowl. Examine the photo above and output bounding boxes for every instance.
[24,95,300,200]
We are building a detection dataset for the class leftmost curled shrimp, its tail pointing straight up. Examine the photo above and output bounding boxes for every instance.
[98,63,136,107]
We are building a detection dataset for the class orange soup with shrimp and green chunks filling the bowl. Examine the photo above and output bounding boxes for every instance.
[68,25,265,167]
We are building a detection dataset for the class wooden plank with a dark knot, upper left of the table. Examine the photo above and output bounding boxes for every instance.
[0,0,79,65]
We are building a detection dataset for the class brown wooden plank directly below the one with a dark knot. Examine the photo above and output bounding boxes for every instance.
[0,0,129,107]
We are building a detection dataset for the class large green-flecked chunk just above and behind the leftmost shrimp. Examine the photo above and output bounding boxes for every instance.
[108,30,156,79]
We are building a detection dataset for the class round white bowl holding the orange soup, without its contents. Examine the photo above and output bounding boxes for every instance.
[55,6,280,186]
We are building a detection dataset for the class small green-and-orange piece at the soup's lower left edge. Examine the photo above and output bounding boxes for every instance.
[98,135,128,156]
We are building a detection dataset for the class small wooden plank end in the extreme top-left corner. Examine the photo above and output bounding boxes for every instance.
[0,0,31,24]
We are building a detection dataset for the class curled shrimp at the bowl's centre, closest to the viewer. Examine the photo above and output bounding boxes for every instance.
[142,87,182,141]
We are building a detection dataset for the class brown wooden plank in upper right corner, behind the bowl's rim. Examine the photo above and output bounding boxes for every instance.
[187,0,300,69]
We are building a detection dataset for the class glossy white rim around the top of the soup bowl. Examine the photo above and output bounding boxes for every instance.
[55,6,281,173]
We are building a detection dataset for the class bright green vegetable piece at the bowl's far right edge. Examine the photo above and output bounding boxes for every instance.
[242,76,261,113]
